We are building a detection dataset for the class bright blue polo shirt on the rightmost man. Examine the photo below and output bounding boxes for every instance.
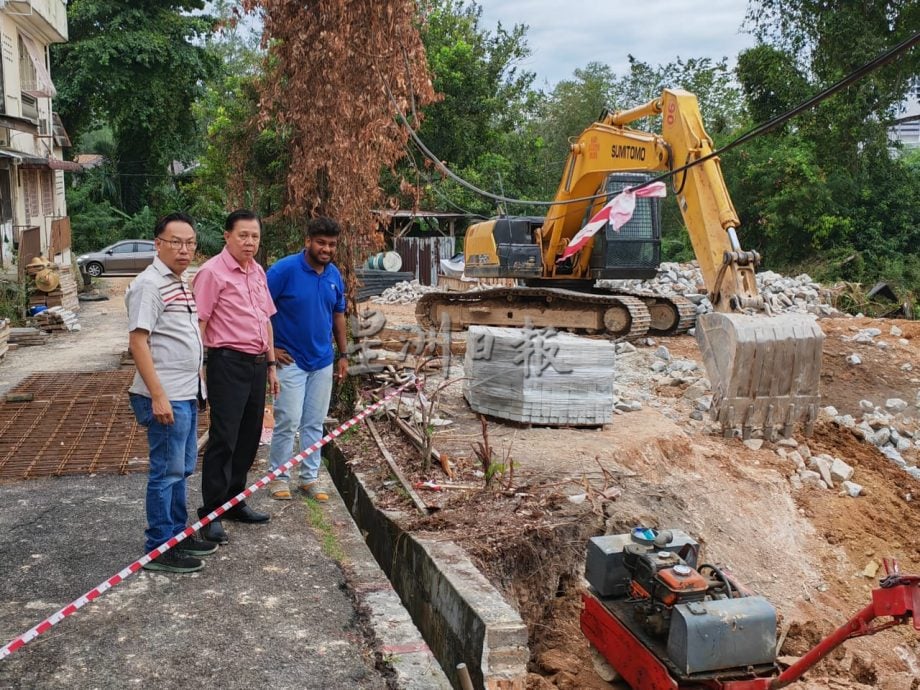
[266,252,345,371]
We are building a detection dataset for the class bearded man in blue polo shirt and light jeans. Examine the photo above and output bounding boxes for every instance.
[267,218,348,501]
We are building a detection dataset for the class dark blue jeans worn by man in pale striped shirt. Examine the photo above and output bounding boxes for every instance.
[131,393,198,552]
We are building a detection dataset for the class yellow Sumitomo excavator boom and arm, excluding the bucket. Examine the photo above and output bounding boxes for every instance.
[542,89,764,312]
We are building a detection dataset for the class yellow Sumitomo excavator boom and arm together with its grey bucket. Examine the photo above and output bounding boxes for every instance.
[541,89,824,438]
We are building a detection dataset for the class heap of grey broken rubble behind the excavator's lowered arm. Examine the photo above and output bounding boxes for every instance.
[597,261,842,316]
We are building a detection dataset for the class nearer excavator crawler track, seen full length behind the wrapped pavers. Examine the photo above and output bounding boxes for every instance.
[415,287,652,340]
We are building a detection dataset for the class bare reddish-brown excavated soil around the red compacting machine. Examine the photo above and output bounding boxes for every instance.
[354,305,920,690]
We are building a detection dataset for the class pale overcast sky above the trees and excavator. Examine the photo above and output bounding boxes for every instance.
[478,0,754,87]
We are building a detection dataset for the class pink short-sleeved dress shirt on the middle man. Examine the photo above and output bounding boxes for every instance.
[192,247,276,355]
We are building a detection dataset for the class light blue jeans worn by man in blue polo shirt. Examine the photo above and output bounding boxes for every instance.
[268,364,333,482]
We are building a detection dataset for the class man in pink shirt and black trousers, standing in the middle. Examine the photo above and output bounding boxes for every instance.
[193,209,280,544]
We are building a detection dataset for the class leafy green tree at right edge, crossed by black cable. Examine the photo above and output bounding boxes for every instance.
[723,0,920,293]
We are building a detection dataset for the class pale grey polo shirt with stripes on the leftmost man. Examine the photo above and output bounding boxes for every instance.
[125,257,204,400]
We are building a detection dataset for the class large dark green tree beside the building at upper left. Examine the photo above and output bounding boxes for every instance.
[52,0,216,213]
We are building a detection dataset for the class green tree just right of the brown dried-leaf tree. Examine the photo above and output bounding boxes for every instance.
[410,0,543,215]
